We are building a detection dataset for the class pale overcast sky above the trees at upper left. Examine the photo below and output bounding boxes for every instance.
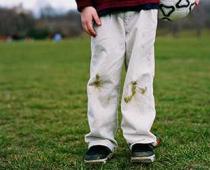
[0,0,76,13]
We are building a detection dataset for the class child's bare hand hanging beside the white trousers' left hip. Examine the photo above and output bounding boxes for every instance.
[81,6,101,37]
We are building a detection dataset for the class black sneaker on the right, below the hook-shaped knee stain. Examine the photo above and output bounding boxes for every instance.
[131,143,155,163]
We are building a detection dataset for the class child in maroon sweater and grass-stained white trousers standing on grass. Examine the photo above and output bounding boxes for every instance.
[76,0,159,163]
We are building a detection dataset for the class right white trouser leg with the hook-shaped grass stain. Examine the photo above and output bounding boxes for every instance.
[121,10,157,148]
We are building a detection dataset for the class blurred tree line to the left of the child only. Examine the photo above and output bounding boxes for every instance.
[0,6,82,40]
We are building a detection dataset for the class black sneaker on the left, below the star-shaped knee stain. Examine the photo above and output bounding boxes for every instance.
[84,145,113,163]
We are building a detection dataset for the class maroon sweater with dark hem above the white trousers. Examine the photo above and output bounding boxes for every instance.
[76,0,160,15]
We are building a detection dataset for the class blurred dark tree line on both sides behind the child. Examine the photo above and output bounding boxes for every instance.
[0,1,210,40]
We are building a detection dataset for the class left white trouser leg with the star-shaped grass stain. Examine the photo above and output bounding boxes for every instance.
[85,15,125,150]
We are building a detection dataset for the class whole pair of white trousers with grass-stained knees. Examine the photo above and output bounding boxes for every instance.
[85,9,157,150]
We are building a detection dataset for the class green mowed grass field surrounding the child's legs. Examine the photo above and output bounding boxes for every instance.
[0,36,210,170]
